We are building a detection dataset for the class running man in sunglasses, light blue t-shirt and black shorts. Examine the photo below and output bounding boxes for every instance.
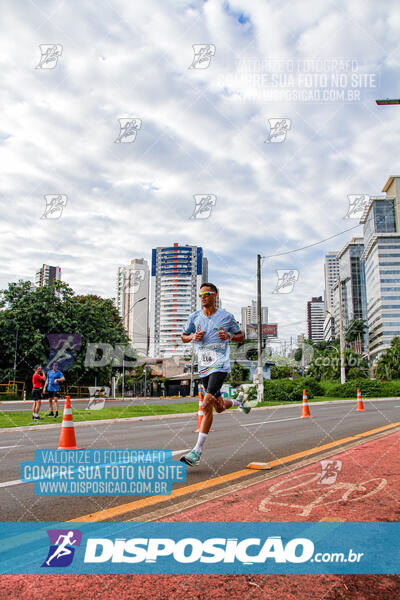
[180,283,250,467]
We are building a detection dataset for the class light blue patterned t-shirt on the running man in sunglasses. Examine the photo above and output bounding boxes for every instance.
[183,308,240,377]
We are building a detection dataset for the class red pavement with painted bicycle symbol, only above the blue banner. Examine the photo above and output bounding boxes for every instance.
[162,431,400,522]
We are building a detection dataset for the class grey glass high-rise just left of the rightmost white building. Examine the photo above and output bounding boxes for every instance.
[334,238,368,352]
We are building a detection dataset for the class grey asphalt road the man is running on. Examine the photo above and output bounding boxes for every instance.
[0,399,400,521]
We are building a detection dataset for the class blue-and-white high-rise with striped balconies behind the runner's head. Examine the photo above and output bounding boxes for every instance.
[150,243,208,356]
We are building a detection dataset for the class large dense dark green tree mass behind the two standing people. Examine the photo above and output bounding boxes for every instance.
[0,281,129,386]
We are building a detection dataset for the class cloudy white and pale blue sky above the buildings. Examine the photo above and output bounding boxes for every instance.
[0,0,400,339]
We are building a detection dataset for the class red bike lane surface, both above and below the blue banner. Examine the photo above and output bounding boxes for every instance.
[0,432,400,600]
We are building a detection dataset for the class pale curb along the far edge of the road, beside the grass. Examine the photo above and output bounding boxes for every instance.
[0,397,400,434]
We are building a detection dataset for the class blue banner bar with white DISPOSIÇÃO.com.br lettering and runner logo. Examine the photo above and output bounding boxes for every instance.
[0,522,400,574]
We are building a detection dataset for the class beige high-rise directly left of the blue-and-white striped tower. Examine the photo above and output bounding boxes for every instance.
[116,258,149,355]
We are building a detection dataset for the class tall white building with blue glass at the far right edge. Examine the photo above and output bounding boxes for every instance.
[360,177,400,361]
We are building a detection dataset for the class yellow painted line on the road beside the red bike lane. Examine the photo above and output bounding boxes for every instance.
[67,421,400,523]
